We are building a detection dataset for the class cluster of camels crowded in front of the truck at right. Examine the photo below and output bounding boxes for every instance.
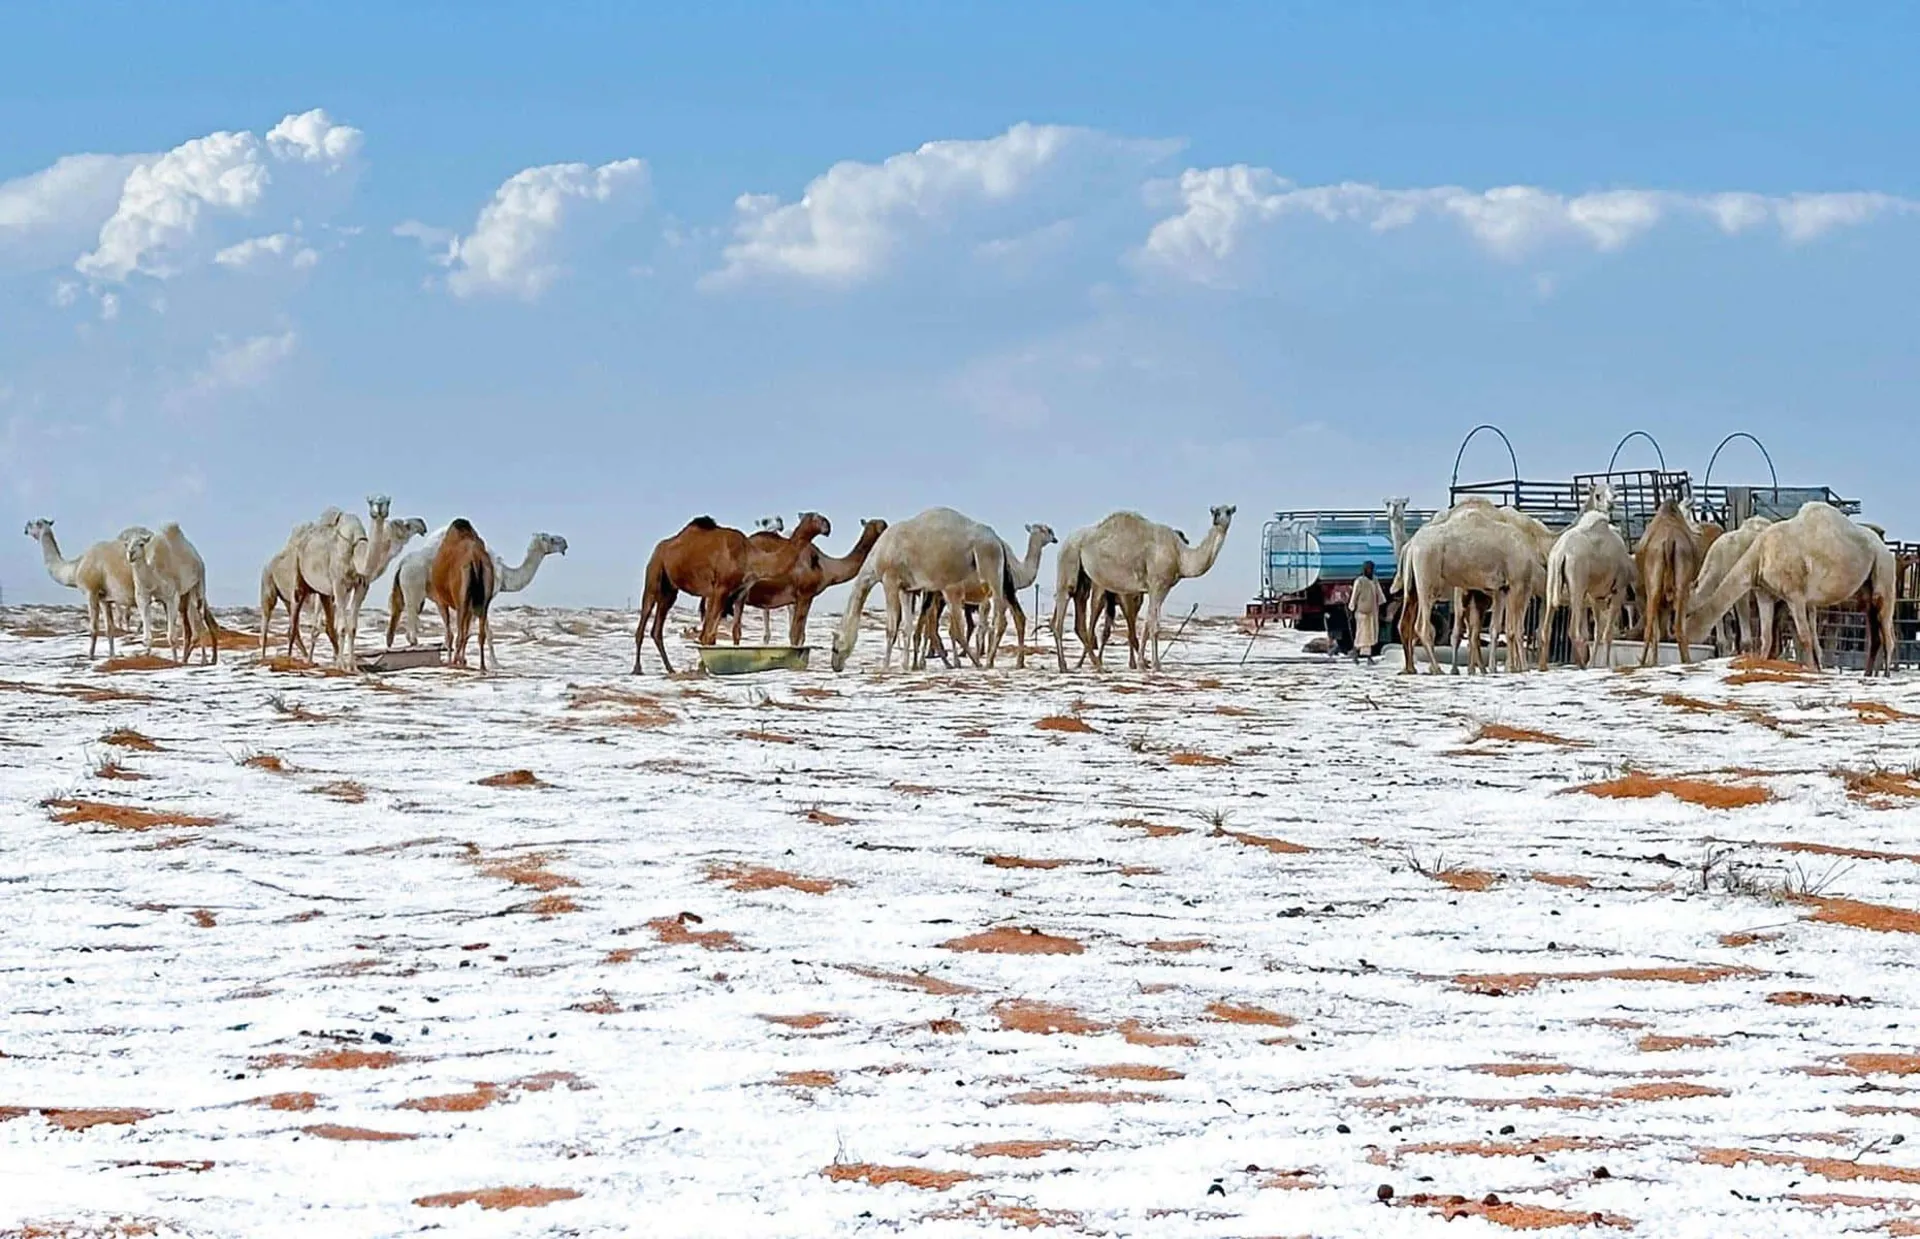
[1386,484,1895,674]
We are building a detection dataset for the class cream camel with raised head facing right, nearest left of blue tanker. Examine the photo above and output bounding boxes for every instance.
[1054,503,1236,670]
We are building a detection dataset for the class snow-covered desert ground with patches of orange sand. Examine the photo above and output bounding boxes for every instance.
[0,609,1920,1237]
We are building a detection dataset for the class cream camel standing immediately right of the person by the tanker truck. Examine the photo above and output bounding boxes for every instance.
[1400,505,1544,674]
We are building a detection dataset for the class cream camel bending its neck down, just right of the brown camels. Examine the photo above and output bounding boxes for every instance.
[833,507,1023,670]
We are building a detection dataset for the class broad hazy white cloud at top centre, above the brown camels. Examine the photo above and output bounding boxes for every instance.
[707,123,1177,286]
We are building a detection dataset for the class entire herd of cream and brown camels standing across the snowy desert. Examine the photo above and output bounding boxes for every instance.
[27,484,1895,674]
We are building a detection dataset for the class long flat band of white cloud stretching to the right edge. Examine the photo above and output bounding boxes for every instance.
[1140,163,1920,280]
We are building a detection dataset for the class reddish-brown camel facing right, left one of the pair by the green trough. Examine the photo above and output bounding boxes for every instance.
[634,513,833,676]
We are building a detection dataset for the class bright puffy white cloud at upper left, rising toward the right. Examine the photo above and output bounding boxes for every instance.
[75,109,361,282]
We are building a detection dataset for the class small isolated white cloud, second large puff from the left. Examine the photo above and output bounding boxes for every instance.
[441,159,649,302]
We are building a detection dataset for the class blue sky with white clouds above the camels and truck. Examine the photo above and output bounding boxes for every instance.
[0,2,1920,607]
